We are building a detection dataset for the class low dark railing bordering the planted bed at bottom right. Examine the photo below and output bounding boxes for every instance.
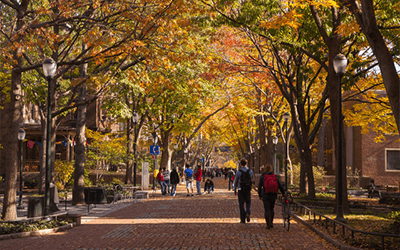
[290,198,400,249]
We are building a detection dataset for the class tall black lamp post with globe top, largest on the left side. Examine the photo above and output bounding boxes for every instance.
[43,58,57,215]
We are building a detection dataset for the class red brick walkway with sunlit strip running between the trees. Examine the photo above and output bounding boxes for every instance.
[0,178,335,250]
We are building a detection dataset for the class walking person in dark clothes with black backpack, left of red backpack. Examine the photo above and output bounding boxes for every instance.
[234,159,253,223]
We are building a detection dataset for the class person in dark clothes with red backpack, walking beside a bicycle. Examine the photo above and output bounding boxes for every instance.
[258,164,286,229]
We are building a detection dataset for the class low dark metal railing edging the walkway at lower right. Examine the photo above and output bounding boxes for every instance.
[284,197,400,249]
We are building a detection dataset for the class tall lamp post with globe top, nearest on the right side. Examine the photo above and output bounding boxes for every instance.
[333,54,347,222]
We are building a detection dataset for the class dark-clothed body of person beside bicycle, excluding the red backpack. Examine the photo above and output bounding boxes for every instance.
[258,164,286,229]
